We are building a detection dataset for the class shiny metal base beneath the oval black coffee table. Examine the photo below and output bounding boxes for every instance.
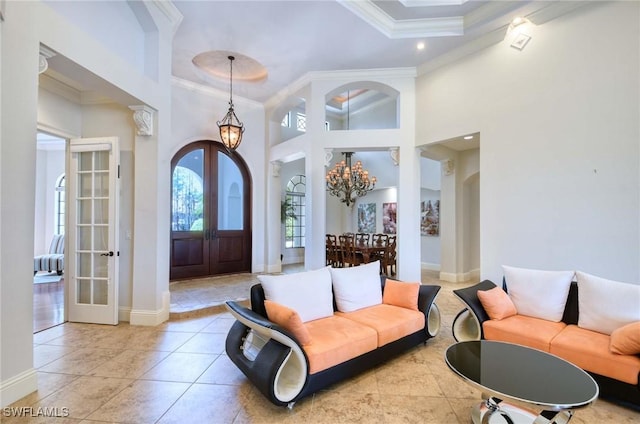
[471,397,573,424]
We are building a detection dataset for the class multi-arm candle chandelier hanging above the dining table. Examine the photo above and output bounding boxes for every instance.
[326,152,377,206]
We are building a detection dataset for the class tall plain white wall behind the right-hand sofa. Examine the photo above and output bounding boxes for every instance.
[416,2,640,283]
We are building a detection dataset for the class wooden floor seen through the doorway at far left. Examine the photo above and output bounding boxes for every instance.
[33,278,64,333]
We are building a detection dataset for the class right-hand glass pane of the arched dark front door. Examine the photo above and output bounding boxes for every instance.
[218,151,244,230]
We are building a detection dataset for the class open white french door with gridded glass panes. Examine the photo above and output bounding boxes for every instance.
[65,137,120,325]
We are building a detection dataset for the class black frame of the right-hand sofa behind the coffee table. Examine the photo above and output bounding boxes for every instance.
[452,280,640,409]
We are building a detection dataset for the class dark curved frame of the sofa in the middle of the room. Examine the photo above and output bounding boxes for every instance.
[226,277,440,408]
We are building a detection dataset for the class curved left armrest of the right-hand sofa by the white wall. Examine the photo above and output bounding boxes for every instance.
[452,280,496,341]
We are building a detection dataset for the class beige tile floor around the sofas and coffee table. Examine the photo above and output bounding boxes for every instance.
[8,273,640,424]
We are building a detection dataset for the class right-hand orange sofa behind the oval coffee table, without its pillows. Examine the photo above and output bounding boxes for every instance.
[452,280,640,407]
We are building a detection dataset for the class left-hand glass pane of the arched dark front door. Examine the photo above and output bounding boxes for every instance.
[171,149,204,231]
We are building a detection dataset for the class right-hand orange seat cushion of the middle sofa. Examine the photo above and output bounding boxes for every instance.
[336,304,425,347]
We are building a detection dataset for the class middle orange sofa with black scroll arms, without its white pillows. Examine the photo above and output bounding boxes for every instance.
[226,263,440,408]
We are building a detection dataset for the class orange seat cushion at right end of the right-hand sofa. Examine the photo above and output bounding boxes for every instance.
[550,325,640,385]
